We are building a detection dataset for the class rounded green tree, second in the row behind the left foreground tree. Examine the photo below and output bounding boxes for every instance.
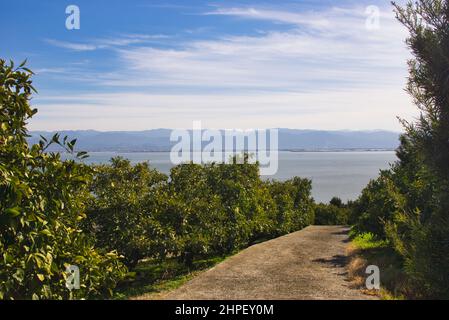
[153,164,226,265]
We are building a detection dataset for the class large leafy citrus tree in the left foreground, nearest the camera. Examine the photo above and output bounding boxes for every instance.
[0,60,125,299]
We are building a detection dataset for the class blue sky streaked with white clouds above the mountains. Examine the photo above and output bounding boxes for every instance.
[0,0,415,131]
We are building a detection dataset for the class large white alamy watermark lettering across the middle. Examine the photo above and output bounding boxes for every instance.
[170,121,278,176]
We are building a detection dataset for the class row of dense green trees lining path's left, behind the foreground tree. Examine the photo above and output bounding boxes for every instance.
[84,158,314,268]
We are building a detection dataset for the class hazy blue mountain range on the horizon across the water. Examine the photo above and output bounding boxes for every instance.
[29,129,399,152]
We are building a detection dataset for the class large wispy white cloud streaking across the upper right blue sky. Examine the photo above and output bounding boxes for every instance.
[103,7,408,91]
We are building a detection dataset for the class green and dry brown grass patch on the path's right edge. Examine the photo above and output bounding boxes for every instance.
[348,233,409,300]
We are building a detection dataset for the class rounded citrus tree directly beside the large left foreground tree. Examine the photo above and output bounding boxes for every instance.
[83,157,167,268]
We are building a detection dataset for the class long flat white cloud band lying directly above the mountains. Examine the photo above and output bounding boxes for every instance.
[31,88,414,130]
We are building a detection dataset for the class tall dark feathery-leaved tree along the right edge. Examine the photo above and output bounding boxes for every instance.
[350,0,449,298]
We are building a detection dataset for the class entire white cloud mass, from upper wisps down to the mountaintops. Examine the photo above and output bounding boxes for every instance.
[36,3,415,130]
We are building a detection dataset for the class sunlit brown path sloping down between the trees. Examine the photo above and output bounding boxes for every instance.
[165,226,373,300]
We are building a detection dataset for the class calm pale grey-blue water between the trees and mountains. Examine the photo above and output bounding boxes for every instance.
[64,151,396,202]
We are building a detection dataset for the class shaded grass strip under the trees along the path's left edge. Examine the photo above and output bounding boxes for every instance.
[116,256,227,299]
